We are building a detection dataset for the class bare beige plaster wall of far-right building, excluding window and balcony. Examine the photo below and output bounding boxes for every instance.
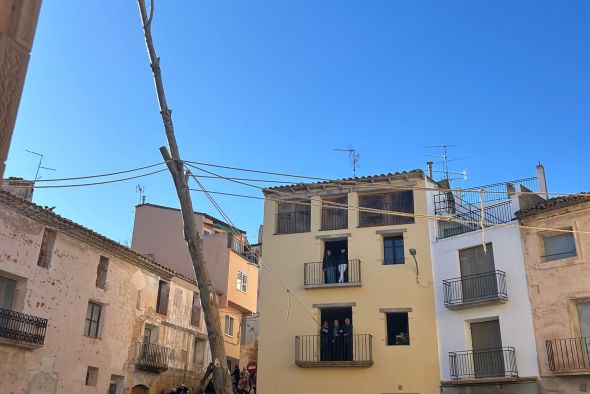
[522,202,590,394]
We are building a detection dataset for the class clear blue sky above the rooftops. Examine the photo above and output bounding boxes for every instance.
[6,0,590,242]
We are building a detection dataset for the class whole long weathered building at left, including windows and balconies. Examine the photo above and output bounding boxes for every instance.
[0,190,210,394]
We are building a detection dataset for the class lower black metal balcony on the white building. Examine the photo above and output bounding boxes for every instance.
[449,346,518,380]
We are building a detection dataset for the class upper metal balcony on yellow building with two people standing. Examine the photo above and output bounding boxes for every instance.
[303,259,361,289]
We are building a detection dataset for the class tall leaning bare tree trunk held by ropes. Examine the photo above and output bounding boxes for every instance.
[137,0,233,394]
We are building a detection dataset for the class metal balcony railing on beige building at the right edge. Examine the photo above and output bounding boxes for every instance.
[545,337,590,375]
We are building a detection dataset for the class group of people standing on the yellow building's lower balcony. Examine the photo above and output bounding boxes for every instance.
[320,317,353,361]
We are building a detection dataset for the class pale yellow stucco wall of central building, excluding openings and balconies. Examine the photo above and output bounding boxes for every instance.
[258,178,440,394]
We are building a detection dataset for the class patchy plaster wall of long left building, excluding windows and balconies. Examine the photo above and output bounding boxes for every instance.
[0,203,207,394]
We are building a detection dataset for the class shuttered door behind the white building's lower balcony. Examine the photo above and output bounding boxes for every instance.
[470,320,504,378]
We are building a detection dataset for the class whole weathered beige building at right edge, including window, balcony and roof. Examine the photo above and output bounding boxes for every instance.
[517,193,590,394]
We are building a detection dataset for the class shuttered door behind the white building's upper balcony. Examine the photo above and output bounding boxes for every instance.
[459,243,498,302]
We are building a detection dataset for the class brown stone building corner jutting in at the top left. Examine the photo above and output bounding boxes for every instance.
[0,0,41,178]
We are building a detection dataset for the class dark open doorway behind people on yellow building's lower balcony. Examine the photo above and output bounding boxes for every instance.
[320,306,354,361]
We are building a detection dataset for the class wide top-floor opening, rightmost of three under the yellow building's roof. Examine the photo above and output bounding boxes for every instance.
[359,191,414,227]
